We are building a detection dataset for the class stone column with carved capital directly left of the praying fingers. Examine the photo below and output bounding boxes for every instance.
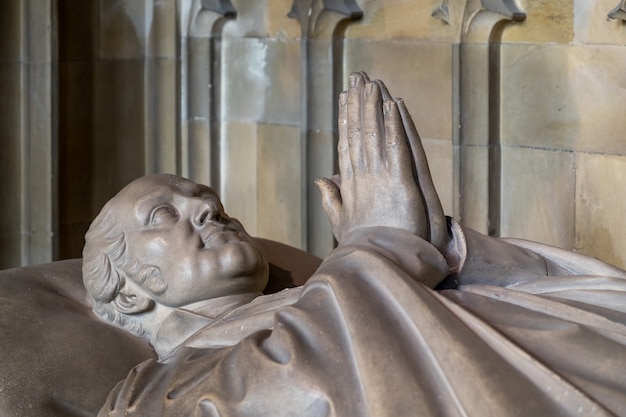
[289,0,363,256]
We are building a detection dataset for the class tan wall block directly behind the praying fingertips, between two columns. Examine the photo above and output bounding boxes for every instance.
[343,39,453,139]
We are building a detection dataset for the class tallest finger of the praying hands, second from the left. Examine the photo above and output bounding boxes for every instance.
[347,73,367,172]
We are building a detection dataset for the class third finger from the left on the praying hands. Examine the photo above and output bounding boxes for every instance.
[362,83,387,171]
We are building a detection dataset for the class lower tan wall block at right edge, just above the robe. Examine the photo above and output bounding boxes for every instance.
[575,153,626,268]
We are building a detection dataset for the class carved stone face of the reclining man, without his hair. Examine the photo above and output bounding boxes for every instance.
[115,175,268,307]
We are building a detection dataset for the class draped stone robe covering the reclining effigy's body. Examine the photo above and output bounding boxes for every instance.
[100,226,626,417]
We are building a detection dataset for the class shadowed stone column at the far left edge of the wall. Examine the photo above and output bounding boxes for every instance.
[0,0,57,268]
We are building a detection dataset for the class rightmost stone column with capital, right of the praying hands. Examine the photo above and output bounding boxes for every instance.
[455,0,526,236]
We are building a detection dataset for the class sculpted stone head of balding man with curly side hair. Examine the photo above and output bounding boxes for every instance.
[83,174,268,337]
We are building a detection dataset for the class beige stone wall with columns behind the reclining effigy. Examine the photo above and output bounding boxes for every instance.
[0,0,626,266]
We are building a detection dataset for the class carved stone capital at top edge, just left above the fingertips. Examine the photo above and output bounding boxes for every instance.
[287,0,363,38]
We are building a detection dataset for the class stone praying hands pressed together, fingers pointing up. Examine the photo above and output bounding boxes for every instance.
[317,73,448,250]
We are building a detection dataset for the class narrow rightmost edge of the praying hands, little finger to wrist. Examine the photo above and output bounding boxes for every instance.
[396,99,449,251]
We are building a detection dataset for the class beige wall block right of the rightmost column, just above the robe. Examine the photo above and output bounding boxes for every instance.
[500,147,576,250]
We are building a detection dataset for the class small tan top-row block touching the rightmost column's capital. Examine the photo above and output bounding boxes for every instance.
[502,0,572,44]
